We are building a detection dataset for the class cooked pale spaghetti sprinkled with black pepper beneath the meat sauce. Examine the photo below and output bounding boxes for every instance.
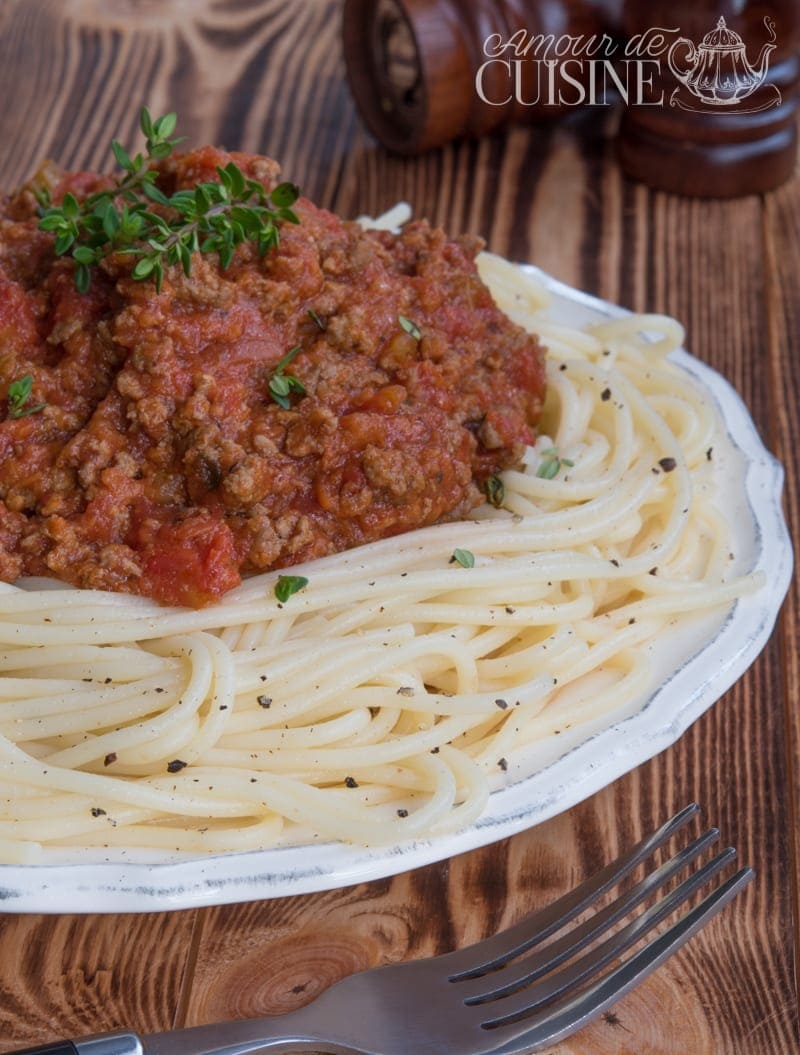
[0,248,758,862]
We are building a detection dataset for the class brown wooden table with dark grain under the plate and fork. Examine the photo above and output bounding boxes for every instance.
[0,0,800,1055]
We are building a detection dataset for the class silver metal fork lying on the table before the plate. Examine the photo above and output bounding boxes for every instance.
[21,804,754,1055]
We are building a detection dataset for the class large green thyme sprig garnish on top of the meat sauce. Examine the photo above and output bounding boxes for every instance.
[37,107,300,293]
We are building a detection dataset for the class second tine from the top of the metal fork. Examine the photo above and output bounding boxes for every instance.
[458,828,720,1004]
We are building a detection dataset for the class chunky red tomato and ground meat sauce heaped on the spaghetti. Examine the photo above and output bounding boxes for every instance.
[0,148,544,606]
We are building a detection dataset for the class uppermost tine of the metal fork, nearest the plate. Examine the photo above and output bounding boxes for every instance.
[439,802,700,981]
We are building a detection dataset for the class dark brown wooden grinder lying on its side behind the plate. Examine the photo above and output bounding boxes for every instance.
[343,0,622,154]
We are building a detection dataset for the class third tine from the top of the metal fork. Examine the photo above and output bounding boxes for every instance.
[482,846,736,1029]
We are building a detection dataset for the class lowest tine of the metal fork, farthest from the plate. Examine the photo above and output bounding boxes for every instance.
[484,868,755,1055]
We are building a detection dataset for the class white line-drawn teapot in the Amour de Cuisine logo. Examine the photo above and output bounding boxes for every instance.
[667,16,776,107]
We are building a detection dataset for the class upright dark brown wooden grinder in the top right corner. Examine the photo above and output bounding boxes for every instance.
[618,0,800,197]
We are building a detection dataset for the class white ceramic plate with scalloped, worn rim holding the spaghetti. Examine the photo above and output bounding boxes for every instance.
[0,268,793,913]
